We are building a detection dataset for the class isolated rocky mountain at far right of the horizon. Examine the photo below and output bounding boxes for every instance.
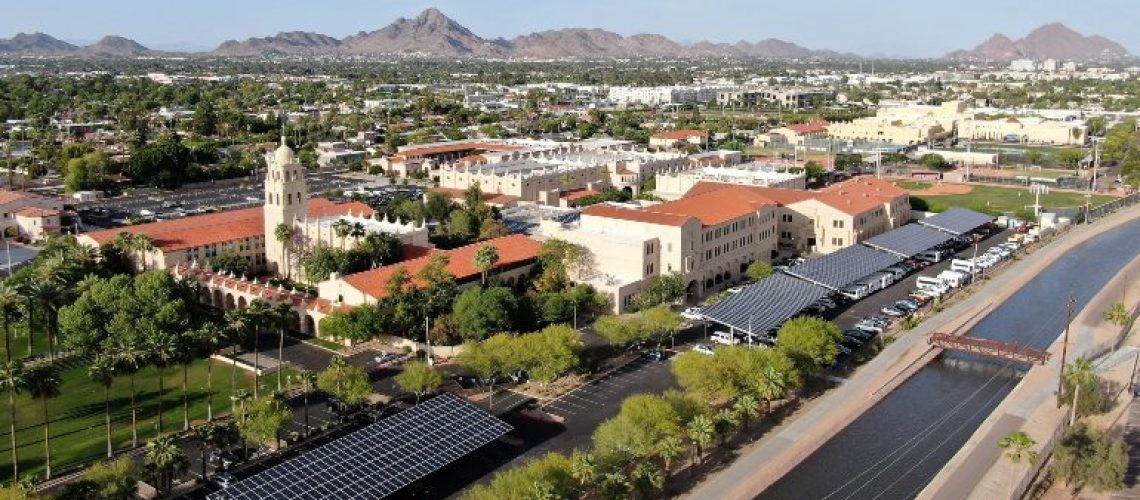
[946,23,1131,62]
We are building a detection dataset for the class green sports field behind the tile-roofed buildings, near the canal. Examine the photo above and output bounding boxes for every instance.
[904,186,1116,215]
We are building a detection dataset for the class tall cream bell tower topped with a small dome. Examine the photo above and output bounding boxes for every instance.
[262,137,309,276]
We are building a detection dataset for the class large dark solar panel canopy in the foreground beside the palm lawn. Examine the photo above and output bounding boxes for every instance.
[209,393,511,500]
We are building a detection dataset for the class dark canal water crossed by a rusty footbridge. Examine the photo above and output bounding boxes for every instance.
[757,221,1140,500]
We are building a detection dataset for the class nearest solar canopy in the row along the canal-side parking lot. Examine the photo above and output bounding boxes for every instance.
[701,273,831,334]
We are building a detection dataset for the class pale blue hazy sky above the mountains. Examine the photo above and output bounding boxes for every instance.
[0,0,1140,57]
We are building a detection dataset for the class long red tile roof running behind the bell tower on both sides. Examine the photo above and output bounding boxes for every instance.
[84,198,376,252]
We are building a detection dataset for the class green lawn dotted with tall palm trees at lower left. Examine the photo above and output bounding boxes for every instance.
[0,351,280,482]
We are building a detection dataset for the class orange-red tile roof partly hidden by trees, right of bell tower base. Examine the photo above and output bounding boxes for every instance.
[342,235,540,300]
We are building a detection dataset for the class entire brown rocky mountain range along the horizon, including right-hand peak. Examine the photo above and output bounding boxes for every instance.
[0,8,1131,62]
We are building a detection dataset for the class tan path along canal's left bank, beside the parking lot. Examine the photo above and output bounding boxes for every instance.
[689,206,1140,499]
